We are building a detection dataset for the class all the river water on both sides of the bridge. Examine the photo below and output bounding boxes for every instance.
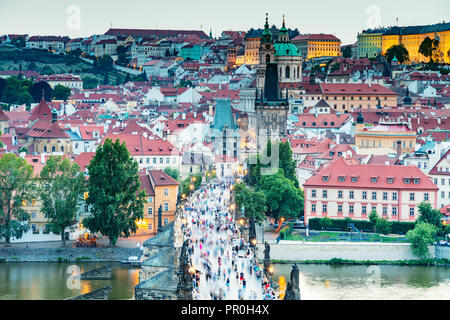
[0,262,450,300]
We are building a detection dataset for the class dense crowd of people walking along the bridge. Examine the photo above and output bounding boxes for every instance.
[183,178,275,300]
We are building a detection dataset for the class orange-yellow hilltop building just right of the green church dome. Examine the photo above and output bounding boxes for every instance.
[292,33,341,60]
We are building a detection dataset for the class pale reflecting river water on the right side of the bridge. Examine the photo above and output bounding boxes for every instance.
[274,264,450,300]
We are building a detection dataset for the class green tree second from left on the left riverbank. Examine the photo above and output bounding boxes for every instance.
[40,156,85,245]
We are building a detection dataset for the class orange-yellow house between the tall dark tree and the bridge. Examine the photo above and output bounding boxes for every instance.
[137,170,179,234]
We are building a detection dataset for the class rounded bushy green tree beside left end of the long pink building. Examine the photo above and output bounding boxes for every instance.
[258,171,304,220]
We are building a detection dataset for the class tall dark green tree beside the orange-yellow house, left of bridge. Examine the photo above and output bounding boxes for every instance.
[83,139,146,246]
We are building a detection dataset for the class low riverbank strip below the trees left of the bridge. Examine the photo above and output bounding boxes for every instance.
[0,247,141,262]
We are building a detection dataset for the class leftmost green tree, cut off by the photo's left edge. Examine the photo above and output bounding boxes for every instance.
[0,153,34,244]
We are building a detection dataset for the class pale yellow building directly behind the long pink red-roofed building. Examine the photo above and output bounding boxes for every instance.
[355,122,417,155]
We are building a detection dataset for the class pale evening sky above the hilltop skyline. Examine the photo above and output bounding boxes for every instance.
[0,0,450,44]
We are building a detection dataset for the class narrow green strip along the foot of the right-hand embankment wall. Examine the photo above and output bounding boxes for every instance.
[271,258,450,267]
